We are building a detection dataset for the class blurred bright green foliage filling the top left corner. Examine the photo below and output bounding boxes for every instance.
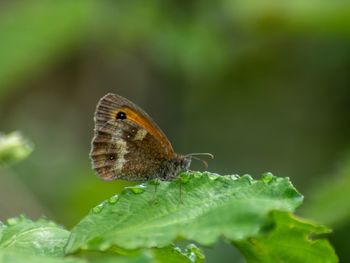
[0,0,92,94]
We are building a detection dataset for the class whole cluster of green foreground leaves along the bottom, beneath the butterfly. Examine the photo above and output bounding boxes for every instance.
[0,167,337,262]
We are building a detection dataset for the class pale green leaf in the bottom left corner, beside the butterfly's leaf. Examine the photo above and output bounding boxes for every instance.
[0,216,69,257]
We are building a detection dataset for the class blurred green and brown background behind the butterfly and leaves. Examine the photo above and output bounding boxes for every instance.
[0,0,350,262]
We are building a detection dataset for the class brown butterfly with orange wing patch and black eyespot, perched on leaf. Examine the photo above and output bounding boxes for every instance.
[90,93,212,181]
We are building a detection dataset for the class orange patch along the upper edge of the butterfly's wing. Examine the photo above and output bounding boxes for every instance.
[113,107,174,152]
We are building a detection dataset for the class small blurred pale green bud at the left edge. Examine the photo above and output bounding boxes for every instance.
[0,132,33,166]
